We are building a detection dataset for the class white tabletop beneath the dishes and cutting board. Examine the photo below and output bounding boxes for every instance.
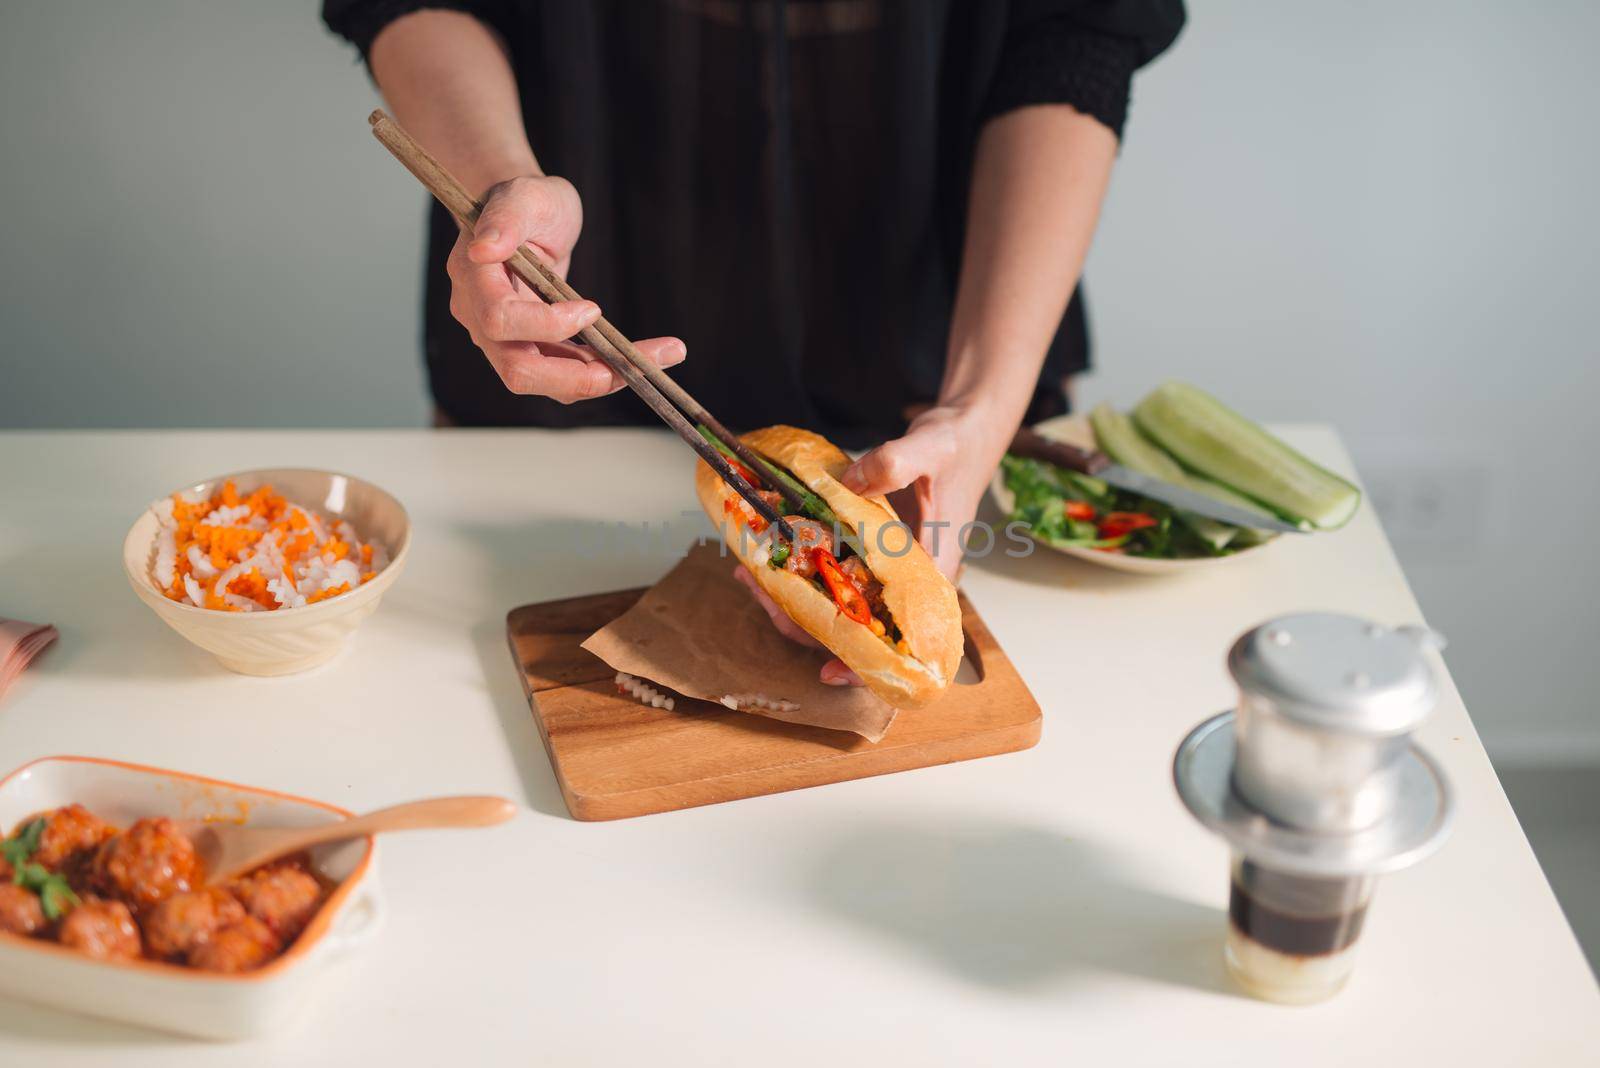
[0,428,1600,1068]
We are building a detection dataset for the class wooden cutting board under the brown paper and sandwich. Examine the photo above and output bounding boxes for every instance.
[506,588,1040,820]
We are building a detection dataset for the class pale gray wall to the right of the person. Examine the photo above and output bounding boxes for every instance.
[1086,0,1600,761]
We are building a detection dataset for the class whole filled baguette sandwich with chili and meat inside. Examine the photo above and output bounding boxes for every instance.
[694,427,962,708]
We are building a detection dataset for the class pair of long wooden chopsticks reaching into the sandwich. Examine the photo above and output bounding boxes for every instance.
[366,107,798,542]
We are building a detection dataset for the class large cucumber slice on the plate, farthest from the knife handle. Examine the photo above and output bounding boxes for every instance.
[1133,382,1362,531]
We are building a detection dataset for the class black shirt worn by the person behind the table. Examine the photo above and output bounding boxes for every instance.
[323,0,1184,446]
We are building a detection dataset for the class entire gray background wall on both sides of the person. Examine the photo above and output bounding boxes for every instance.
[0,0,1600,759]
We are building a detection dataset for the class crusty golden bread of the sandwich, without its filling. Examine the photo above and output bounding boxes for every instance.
[694,427,962,708]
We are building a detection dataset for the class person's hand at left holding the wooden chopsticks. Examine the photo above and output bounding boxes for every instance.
[446,176,686,404]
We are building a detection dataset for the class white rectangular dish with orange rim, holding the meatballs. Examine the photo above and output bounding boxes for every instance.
[0,756,382,1039]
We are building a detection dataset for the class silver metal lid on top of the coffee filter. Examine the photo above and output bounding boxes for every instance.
[1227,612,1443,735]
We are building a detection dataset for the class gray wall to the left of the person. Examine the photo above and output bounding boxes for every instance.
[0,0,427,427]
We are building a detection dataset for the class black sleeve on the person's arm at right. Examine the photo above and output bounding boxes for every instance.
[982,0,1184,137]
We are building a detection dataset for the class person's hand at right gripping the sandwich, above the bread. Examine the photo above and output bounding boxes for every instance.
[840,404,1014,582]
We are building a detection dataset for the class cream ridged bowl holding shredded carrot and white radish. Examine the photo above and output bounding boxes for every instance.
[122,467,411,675]
